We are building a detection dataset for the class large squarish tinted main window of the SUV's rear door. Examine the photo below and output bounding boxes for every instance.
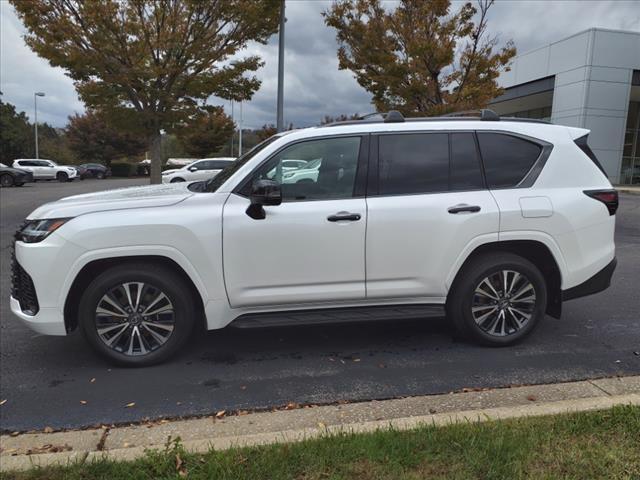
[378,133,449,195]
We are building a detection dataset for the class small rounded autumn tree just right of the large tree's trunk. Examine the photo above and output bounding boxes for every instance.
[179,107,235,158]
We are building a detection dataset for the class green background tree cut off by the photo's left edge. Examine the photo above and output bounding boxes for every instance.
[0,96,35,165]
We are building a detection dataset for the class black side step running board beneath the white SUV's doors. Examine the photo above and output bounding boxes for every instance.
[231,304,445,328]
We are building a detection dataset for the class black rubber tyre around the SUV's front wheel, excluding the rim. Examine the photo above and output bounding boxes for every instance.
[78,263,195,367]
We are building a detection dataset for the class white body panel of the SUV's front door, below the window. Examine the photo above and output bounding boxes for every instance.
[223,194,367,307]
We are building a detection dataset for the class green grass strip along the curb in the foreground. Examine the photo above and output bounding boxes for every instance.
[5,406,640,480]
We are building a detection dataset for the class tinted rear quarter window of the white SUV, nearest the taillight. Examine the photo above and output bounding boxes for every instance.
[478,132,542,188]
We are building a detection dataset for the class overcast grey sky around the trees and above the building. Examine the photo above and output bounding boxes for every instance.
[0,0,640,128]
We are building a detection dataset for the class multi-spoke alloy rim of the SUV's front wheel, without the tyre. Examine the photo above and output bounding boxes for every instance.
[95,282,175,356]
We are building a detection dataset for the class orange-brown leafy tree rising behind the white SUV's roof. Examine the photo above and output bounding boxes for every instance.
[323,0,516,115]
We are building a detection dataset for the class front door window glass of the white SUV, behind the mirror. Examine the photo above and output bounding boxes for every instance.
[248,137,361,201]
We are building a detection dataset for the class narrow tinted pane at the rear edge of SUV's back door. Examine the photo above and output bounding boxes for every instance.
[449,133,484,190]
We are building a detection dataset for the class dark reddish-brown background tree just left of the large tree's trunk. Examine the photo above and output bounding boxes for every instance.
[66,110,146,167]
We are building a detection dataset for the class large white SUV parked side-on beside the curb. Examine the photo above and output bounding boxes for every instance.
[11,111,618,365]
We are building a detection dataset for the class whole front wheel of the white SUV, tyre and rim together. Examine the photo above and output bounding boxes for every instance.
[79,263,195,366]
